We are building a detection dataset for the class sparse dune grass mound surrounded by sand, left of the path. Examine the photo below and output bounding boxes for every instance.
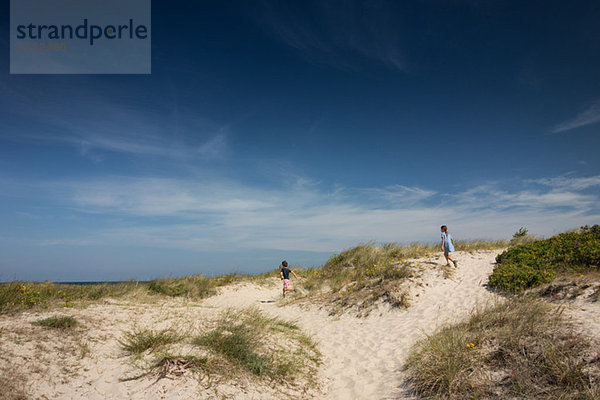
[121,309,321,387]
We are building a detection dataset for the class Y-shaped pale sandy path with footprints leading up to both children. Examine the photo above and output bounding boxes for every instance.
[203,251,498,399]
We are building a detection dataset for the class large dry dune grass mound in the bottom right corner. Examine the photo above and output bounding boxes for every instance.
[405,297,600,400]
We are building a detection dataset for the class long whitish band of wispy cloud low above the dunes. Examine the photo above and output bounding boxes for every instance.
[8,173,600,251]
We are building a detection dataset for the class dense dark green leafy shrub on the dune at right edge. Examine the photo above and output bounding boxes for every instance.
[489,225,600,292]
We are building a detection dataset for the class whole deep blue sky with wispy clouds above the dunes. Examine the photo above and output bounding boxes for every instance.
[0,0,600,281]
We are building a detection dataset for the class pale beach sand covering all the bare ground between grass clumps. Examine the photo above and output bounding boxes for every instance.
[0,251,600,400]
